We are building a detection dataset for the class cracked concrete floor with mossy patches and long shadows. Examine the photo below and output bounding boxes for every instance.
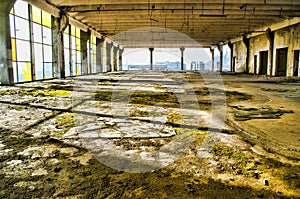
[0,71,300,198]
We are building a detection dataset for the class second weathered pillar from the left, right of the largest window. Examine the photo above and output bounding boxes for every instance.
[52,15,69,78]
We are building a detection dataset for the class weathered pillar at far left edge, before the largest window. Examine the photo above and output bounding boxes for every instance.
[0,0,15,85]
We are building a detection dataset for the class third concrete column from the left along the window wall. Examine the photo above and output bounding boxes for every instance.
[80,30,91,75]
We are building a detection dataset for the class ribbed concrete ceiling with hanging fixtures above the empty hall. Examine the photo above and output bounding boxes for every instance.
[47,0,300,47]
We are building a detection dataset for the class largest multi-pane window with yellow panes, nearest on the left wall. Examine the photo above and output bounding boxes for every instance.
[10,0,53,82]
